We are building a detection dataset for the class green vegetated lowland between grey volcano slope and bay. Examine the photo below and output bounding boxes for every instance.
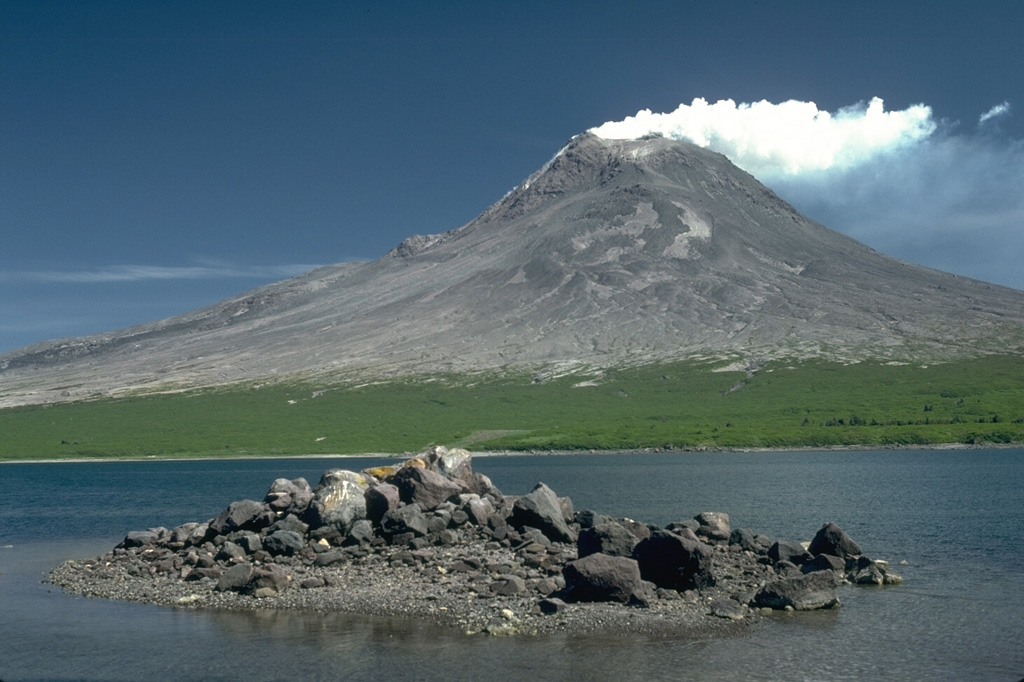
[0,355,1024,459]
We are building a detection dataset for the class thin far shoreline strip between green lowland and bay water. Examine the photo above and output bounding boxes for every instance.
[0,442,1024,465]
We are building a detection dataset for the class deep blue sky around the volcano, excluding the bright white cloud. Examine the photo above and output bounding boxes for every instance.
[0,0,1024,351]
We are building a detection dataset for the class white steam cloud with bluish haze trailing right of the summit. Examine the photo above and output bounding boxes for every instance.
[591,97,1024,289]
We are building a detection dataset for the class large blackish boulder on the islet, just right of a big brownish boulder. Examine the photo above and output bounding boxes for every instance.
[633,530,715,590]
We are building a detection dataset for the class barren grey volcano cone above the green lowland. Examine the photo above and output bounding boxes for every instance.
[0,134,1024,406]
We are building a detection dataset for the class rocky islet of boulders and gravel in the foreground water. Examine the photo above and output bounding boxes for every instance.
[49,447,901,634]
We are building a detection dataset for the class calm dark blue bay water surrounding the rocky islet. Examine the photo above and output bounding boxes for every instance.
[0,450,1024,682]
